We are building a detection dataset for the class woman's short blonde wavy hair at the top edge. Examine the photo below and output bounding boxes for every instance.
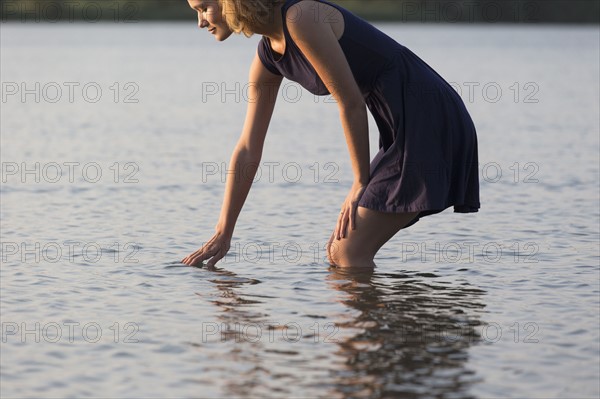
[219,0,285,37]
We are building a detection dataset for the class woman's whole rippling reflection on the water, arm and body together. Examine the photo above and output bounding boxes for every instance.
[192,268,485,398]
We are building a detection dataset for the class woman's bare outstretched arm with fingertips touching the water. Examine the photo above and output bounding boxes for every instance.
[182,51,282,267]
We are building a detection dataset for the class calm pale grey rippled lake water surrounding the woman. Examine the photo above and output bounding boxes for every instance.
[0,23,600,398]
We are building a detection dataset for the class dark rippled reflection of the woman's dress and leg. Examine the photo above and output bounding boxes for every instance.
[329,268,485,398]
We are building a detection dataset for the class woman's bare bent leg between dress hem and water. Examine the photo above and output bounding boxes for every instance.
[327,206,418,268]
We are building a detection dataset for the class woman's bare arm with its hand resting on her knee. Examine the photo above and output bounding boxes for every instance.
[287,2,370,240]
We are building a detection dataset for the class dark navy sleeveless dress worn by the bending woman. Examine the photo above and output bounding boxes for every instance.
[258,0,480,224]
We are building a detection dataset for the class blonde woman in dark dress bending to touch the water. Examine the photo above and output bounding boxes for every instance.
[182,0,479,268]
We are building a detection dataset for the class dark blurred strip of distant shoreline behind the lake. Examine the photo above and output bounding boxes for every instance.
[0,0,600,25]
